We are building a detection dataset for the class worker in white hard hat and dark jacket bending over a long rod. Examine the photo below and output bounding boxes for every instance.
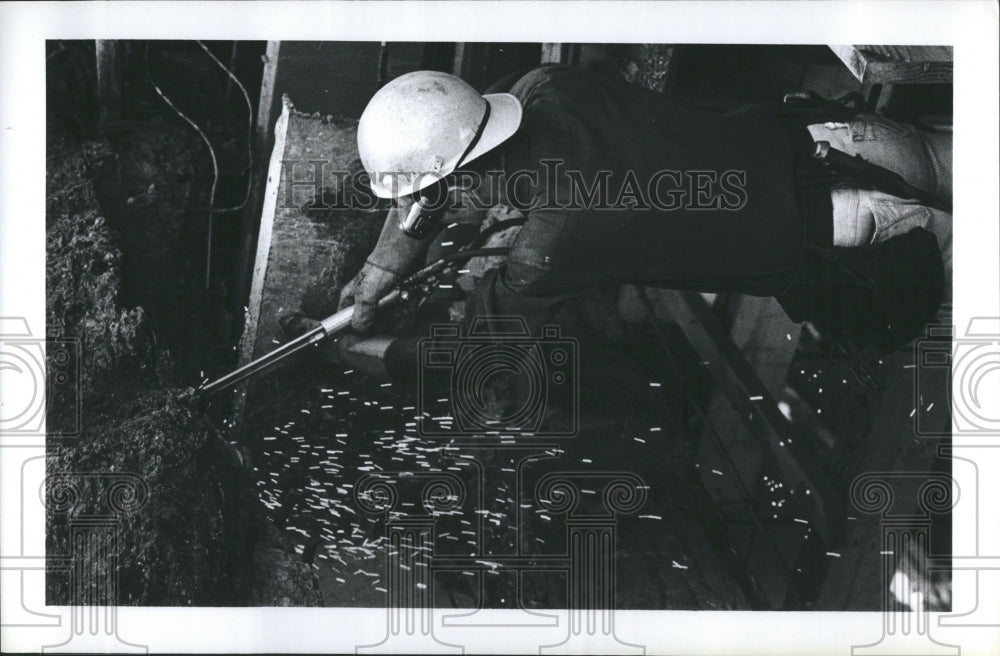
[280,66,951,394]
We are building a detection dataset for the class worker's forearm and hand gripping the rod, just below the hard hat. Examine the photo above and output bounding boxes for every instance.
[338,199,433,333]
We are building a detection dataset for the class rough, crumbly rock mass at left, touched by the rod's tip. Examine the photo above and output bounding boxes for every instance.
[46,135,322,606]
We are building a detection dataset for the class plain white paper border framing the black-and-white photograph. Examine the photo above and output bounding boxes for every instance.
[0,0,1000,654]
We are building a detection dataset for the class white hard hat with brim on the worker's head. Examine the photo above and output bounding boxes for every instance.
[358,71,521,198]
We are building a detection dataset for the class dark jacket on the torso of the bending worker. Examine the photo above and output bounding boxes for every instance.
[492,66,805,295]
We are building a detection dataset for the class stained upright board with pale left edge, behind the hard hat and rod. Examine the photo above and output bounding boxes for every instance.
[233,101,385,451]
